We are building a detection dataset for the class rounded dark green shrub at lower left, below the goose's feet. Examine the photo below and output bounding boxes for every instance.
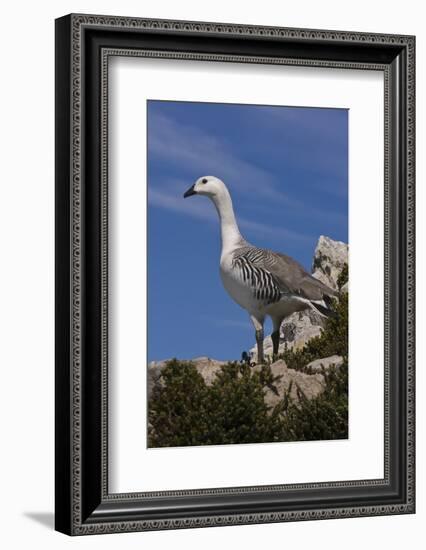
[148,360,280,447]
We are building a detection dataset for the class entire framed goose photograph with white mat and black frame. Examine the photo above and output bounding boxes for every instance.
[55,14,415,535]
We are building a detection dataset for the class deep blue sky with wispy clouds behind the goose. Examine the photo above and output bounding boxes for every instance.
[148,100,348,361]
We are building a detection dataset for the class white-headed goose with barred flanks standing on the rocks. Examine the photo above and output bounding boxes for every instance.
[183,176,338,364]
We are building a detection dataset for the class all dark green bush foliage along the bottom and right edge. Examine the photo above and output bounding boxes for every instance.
[148,270,348,447]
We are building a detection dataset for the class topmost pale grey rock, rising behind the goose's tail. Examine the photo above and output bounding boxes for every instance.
[312,235,348,290]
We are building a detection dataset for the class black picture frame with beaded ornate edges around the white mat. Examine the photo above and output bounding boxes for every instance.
[55,14,415,535]
